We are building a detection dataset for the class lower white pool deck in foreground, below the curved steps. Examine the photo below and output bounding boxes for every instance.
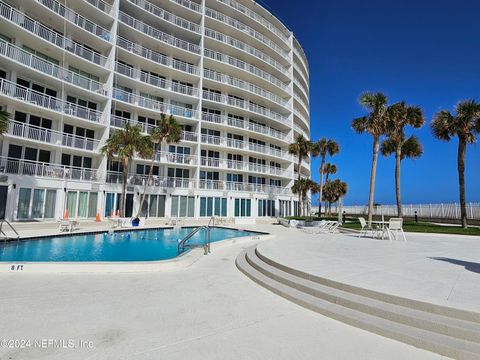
[0,225,441,360]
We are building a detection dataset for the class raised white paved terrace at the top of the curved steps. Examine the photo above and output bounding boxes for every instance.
[259,230,480,312]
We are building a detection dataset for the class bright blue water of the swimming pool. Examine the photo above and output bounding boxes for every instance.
[0,227,257,262]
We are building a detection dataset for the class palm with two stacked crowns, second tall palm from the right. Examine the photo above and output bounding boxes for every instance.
[380,101,425,217]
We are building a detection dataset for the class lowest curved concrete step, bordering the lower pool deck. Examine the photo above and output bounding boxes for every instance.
[236,248,480,360]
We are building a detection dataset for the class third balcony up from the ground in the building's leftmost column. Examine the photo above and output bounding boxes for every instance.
[0,79,102,123]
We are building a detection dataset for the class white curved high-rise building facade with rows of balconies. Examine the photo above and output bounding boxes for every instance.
[0,0,310,220]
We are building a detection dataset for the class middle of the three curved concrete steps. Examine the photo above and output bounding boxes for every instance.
[246,248,480,343]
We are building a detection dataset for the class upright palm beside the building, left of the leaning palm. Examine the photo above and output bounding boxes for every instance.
[100,123,152,217]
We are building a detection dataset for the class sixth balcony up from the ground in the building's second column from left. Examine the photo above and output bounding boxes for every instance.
[117,36,200,75]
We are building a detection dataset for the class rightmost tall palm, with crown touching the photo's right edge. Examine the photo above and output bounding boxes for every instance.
[431,100,480,229]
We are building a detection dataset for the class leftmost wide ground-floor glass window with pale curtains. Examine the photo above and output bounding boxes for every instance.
[17,188,57,219]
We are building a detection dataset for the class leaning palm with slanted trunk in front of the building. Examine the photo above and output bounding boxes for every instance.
[136,113,182,218]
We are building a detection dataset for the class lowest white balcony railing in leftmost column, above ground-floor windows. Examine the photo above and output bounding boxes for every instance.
[0,157,103,182]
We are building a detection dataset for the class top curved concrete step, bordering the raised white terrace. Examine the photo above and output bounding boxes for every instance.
[256,249,480,324]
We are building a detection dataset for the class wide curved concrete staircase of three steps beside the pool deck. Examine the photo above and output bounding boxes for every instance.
[236,246,480,359]
